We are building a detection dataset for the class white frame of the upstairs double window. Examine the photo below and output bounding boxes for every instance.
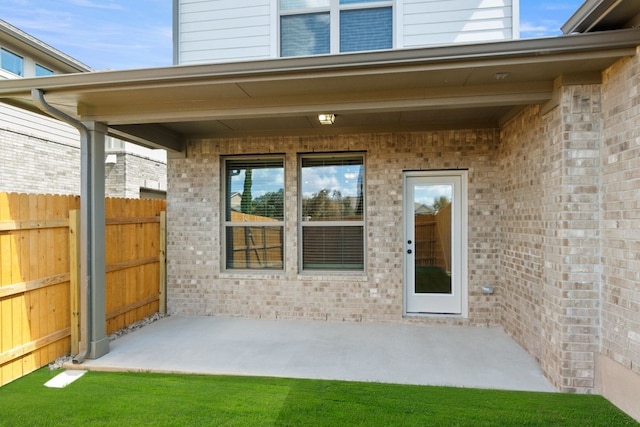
[277,0,398,58]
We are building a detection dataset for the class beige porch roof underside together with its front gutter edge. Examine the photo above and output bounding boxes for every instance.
[0,29,640,151]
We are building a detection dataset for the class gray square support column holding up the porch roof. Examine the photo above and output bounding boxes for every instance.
[80,122,109,359]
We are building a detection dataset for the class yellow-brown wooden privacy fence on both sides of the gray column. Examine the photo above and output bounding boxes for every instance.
[0,193,166,385]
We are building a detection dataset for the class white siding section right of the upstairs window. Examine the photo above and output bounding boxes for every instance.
[398,0,518,48]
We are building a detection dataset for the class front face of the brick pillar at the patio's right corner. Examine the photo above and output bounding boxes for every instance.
[546,85,602,392]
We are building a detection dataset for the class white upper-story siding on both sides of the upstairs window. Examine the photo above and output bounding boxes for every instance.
[175,0,519,64]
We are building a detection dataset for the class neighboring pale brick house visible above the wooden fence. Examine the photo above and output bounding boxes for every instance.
[0,20,167,198]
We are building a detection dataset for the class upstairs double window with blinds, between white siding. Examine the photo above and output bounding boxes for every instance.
[280,0,393,57]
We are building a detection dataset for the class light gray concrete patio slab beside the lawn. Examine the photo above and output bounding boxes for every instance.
[74,316,554,391]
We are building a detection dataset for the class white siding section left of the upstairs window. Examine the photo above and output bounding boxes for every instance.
[178,0,276,64]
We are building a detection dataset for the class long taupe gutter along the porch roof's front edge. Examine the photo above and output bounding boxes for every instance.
[0,29,640,97]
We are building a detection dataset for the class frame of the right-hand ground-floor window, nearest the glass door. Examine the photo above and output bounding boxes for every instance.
[297,151,368,275]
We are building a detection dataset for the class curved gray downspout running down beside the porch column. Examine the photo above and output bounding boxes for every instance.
[31,89,93,364]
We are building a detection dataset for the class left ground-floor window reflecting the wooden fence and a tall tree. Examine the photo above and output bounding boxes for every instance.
[224,158,284,270]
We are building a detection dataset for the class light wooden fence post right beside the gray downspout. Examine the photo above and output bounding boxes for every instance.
[69,209,82,355]
